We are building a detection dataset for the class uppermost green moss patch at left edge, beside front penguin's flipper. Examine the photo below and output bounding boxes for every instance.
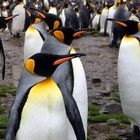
[0,85,16,97]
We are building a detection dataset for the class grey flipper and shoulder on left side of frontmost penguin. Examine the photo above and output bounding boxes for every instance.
[5,68,45,140]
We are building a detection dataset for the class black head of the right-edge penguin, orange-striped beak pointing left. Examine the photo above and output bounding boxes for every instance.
[107,19,140,35]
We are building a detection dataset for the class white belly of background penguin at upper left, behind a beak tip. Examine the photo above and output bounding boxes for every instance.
[10,4,25,35]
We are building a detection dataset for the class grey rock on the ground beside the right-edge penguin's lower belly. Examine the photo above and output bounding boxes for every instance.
[100,100,122,114]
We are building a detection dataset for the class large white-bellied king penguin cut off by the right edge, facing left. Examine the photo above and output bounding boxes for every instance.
[110,19,140,140]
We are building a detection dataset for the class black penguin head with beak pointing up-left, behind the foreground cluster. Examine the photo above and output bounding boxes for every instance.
[27,7,62,30]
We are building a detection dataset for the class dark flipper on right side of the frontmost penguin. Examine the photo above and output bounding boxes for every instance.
[60,83,86,140]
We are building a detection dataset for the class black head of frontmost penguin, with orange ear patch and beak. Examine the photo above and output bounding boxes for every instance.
[25,53,85,77]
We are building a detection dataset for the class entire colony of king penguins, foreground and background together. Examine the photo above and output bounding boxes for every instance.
[0,0,140,140]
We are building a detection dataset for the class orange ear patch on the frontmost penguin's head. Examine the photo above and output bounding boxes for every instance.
[25,59,35,75]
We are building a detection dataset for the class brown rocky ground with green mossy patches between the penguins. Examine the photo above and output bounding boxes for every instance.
[0,32,132,140]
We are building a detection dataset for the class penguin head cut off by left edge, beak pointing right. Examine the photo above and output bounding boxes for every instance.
[0,15,18,29]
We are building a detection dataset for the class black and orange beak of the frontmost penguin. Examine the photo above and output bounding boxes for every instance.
[53,53,86,66]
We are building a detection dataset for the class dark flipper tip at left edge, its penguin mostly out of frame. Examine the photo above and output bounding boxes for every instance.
[0,39,5,79]
